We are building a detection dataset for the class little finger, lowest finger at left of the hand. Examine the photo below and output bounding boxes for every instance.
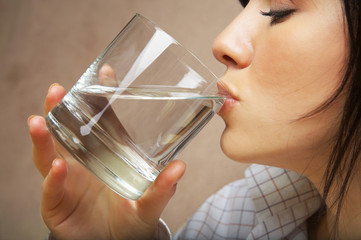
[41,159,68,219]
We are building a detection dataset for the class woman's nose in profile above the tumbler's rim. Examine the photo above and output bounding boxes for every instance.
[212,14,253,69]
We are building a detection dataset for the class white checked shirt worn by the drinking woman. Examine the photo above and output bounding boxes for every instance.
[169,165,321,240]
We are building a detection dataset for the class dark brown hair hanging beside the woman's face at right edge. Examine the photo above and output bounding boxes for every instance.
[322,0,361,237]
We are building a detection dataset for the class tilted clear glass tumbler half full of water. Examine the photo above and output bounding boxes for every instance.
[46,14,227,200]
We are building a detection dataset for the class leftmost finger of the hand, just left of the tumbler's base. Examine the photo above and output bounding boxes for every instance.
[28,116,56,177]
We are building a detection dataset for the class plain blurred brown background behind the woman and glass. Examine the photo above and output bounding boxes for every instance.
[0,0,245,240]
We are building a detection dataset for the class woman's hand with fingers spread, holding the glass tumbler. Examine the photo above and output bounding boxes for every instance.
[28,84,185,239]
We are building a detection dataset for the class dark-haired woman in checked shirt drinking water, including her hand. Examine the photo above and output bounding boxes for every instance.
[29,0,361,239]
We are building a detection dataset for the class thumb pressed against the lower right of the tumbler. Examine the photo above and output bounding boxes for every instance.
[137,160,186,221]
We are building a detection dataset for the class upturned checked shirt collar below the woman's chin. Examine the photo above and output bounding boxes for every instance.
[245,164,321,239]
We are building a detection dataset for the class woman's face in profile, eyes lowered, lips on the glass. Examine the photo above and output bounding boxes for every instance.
[213,0,347,171]
